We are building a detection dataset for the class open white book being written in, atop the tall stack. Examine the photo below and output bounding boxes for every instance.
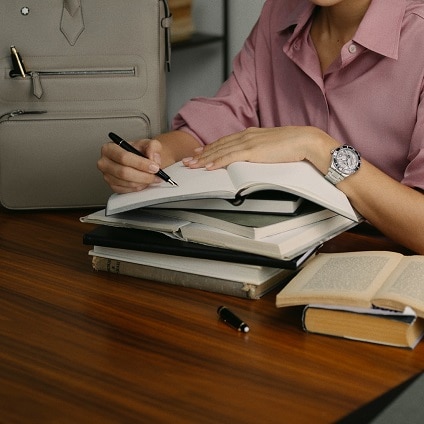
[106,161,360,221]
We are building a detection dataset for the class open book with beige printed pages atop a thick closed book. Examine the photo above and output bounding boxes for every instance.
[276,251,424,318]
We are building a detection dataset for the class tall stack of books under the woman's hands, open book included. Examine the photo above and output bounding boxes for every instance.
[81,162,361,299]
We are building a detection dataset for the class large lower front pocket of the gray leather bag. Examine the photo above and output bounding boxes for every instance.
[0,112,151,209]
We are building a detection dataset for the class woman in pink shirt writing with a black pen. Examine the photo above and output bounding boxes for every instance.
[98,0,424,254]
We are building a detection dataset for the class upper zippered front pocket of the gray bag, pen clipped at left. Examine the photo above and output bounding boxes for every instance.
[0,56,147,103]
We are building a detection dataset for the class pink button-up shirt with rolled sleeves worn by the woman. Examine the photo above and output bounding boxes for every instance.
[173,0,424,189]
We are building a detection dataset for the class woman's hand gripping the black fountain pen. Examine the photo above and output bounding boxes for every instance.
[97,140,162,193]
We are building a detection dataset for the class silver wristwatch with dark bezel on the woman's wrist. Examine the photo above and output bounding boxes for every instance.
[325,144,361,184]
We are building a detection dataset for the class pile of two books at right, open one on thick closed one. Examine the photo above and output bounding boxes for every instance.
[276,251,424,348]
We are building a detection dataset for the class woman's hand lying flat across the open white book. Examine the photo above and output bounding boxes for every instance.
[183,126,339,172]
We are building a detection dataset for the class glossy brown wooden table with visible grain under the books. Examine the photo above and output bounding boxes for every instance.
[0,209,424,424]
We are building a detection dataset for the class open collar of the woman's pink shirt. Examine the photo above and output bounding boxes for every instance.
[279,0,406,59]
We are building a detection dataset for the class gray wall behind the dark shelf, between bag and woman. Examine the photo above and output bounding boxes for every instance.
[167,0,265,125]
